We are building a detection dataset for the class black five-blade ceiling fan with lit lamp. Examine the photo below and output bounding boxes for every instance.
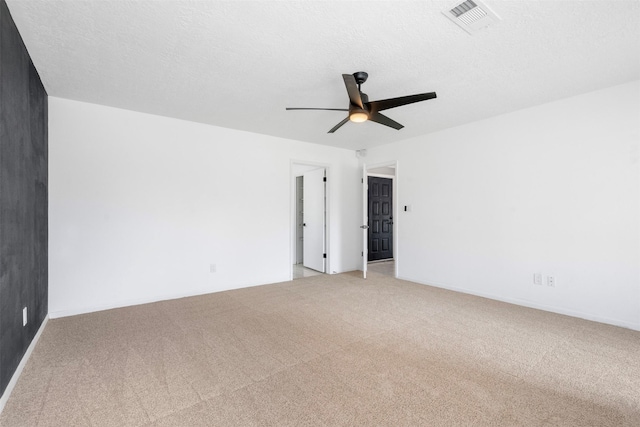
[287,71,436,133]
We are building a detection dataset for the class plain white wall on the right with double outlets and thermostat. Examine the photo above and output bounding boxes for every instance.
[364,81,640,329]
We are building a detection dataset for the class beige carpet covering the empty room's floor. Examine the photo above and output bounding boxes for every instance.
[0,273,640,426]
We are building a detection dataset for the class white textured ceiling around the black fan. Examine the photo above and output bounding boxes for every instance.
[7,0,640,149]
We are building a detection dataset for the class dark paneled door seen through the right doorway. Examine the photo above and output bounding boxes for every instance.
[368,176,393,261]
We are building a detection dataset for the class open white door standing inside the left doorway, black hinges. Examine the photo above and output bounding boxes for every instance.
[302,168,325,273]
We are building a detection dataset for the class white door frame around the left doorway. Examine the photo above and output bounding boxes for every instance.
[289,159,332,280]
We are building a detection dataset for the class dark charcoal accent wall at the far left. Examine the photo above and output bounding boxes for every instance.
[0,0,48,395]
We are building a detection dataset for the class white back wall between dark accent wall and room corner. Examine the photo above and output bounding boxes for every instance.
[49,97,361,318]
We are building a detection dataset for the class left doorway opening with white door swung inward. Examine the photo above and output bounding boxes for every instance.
[291,164,328,279]
